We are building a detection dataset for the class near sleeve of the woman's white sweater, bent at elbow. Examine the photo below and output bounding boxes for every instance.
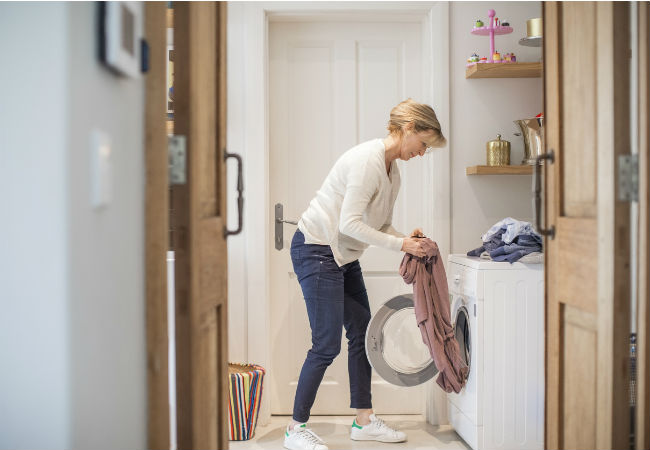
[339,164,403,251]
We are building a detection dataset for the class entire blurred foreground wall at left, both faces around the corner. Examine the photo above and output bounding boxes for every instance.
[0,3,146,449]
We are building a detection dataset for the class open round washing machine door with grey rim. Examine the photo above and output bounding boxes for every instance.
[366,294,438,386]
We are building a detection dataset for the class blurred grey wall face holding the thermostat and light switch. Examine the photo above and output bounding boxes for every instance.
[67,2,147,449]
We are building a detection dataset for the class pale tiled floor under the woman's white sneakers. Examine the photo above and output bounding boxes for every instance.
[230,415,469,450]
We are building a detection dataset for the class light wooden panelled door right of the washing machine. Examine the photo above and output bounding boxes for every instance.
[543,2,630,448]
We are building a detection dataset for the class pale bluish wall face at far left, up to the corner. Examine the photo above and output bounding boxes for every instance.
[0,3,71,449]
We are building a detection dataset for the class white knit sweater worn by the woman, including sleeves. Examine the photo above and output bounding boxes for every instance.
[298,139,405,266]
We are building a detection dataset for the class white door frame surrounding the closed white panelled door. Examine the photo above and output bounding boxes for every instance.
[228,2,451,423]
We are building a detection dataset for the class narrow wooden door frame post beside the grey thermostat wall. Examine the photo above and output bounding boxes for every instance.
[145,2,170,449]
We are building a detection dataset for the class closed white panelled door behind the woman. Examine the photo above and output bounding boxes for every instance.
[269,21,433,414]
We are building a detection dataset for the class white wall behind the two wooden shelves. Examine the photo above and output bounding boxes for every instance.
[449,2,543,253]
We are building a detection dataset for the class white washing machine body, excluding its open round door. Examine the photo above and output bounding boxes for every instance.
[447,255,544,450]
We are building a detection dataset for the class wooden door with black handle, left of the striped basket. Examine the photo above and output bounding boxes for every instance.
[171,2,228,449]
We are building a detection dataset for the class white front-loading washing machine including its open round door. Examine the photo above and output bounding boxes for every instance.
[366,255,544,450]
